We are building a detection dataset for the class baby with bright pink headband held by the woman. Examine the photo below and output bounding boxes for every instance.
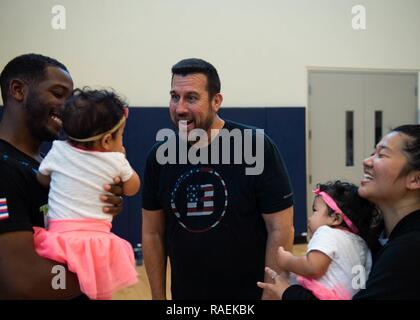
[258,181,380,300]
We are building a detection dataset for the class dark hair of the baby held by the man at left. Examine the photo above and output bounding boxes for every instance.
[62,88,127,148]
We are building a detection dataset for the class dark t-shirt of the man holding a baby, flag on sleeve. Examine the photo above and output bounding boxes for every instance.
[0,140,48,233]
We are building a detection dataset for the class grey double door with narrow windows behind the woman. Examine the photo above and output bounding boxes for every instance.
[308,71,417,220]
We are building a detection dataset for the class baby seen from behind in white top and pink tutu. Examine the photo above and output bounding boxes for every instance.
[34,89,140,299]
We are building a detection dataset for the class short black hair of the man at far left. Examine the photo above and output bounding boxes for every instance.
[0,53,68,104]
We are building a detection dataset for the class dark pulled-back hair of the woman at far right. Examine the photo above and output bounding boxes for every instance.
[391,124,420,175]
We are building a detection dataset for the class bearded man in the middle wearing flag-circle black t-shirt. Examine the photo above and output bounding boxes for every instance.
[142,59,293,300]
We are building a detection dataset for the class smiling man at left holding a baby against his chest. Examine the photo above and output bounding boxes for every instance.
[0,54,122,299]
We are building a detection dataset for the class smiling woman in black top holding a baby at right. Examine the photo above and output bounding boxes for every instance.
[271,125,420,300]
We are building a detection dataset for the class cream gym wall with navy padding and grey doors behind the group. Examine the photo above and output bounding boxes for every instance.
[0,0,420,246]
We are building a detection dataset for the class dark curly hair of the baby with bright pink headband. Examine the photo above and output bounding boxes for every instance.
[317,180,381,249]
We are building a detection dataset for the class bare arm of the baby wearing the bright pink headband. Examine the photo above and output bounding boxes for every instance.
[277,247,331,278]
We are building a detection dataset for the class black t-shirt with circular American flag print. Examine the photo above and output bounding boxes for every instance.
[143,121,293,299]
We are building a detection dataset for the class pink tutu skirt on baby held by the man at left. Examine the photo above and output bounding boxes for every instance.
[34,219,137,299]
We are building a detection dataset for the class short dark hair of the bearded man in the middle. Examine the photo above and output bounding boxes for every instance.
[172,58,221,99]
